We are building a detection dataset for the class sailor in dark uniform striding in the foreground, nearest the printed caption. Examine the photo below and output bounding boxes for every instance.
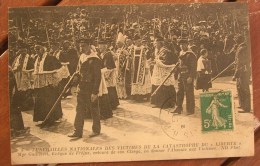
[69,39,102,138]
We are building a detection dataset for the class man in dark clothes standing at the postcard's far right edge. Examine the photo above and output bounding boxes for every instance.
[233,35,251,113]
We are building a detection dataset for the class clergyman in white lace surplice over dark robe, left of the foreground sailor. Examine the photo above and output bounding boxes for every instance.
[33,42,63,127]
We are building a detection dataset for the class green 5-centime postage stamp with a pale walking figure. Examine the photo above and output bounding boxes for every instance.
[200,91,234,131]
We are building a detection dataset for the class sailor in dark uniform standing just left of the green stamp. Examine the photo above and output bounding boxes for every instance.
[173,39,197,115]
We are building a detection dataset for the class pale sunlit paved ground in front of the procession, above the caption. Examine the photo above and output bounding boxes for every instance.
[11,77,253,163]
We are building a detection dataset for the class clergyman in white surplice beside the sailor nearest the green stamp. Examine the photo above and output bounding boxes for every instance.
[151,37,177,108]
